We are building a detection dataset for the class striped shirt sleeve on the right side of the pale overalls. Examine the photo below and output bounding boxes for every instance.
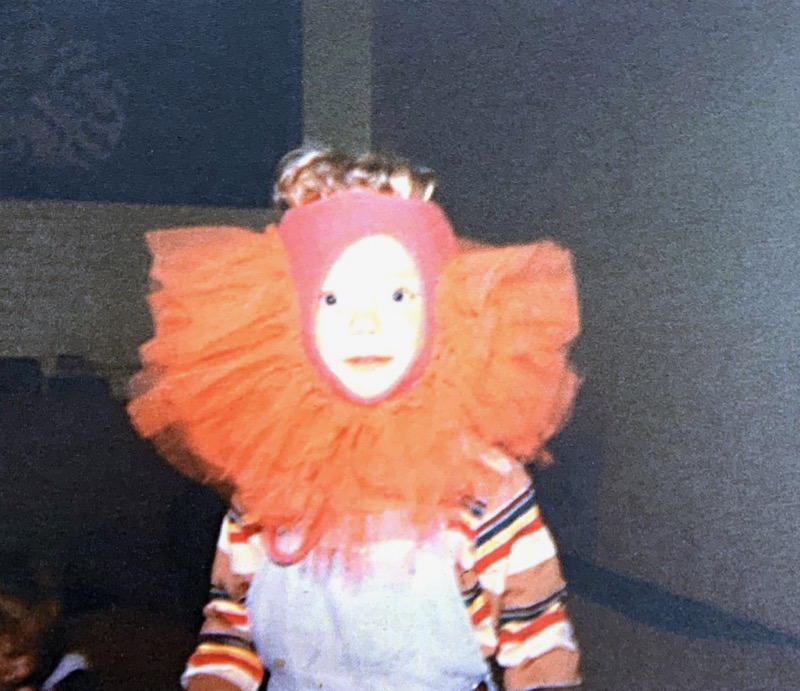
[460,468,581,691]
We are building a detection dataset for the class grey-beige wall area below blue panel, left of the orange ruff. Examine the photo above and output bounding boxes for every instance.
[0,200,276,396]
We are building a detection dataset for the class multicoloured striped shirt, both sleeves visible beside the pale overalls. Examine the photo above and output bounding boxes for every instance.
[182,469,580,691]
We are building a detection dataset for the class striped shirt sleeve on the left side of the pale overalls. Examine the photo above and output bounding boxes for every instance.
[181,510,264,691]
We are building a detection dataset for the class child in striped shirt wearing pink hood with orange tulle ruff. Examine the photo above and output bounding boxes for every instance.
[129,143,580,691]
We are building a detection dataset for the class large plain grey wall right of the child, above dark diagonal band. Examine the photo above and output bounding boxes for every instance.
[374,0,800,629]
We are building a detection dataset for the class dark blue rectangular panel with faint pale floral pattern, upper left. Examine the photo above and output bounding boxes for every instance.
[0,0,302,206]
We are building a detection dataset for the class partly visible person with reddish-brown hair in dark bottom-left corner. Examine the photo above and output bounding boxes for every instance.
[0,550,95,691]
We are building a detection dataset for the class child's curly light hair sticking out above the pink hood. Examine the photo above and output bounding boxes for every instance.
[273,146,436,208]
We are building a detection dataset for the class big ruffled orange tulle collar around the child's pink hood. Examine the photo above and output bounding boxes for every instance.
[128,227,578,562]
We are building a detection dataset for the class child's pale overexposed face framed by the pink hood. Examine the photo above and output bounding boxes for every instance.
[314,235,425,400]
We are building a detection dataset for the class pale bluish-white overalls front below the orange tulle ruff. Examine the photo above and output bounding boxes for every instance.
[247,532,493,691]
